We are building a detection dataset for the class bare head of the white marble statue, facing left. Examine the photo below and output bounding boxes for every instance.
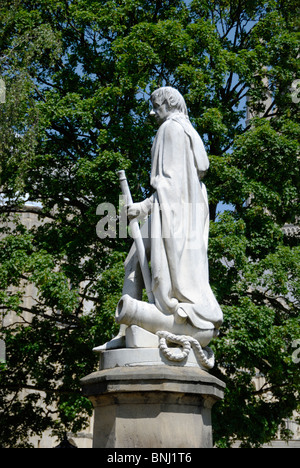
[150,86,188,123]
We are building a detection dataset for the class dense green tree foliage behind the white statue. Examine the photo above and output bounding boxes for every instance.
[0,0,300,447]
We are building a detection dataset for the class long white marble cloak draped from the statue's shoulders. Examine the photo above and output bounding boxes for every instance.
[151,114,223,329]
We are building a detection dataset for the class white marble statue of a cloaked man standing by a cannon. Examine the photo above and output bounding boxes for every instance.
[96,87,223,366]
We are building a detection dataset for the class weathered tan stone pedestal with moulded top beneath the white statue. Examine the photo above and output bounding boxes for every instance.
[81,349,225,448]
